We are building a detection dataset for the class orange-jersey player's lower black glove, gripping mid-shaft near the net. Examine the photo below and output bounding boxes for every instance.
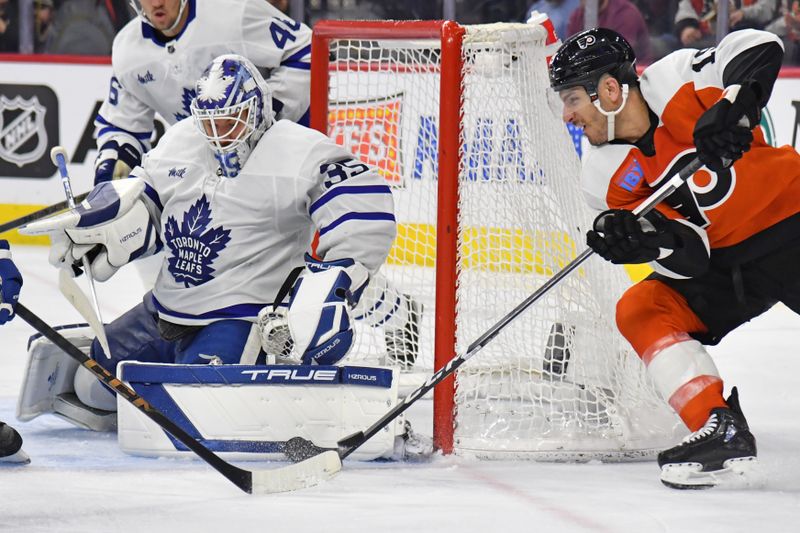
[586,209,675,265]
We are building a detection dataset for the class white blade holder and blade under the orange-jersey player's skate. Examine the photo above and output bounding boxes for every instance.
[661,457,766,490]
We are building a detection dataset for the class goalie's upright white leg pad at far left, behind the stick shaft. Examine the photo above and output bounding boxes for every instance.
[17,324,94,421]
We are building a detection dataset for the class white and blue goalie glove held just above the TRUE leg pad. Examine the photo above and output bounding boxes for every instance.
[288,254,369,365]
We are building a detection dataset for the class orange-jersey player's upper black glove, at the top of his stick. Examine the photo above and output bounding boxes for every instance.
[694,82,761,172]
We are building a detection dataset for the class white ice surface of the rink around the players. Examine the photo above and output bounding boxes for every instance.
[0,246,800,533]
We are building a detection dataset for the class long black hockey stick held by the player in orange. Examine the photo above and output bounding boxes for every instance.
[278,157,703,486]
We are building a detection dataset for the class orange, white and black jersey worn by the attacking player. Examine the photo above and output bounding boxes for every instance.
[581,30,800,278]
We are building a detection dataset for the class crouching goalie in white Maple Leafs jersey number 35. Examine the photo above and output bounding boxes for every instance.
[27,55,396,424]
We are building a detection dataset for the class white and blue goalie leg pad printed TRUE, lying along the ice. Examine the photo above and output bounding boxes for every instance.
[117,361,406,461]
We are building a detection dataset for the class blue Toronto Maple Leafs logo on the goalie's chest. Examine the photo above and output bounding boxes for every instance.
[164,195,231,288]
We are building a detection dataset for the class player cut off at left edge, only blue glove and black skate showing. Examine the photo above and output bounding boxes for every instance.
[0,240,30,465]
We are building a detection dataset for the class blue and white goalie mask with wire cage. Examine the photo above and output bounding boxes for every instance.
[191,54,273,178]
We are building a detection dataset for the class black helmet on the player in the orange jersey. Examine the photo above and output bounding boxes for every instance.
[550,28,639,100]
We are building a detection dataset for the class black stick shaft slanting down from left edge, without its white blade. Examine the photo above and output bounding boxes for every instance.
[16,303,253,493]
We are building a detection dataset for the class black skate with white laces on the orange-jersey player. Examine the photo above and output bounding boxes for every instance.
[658,387,763,489]
